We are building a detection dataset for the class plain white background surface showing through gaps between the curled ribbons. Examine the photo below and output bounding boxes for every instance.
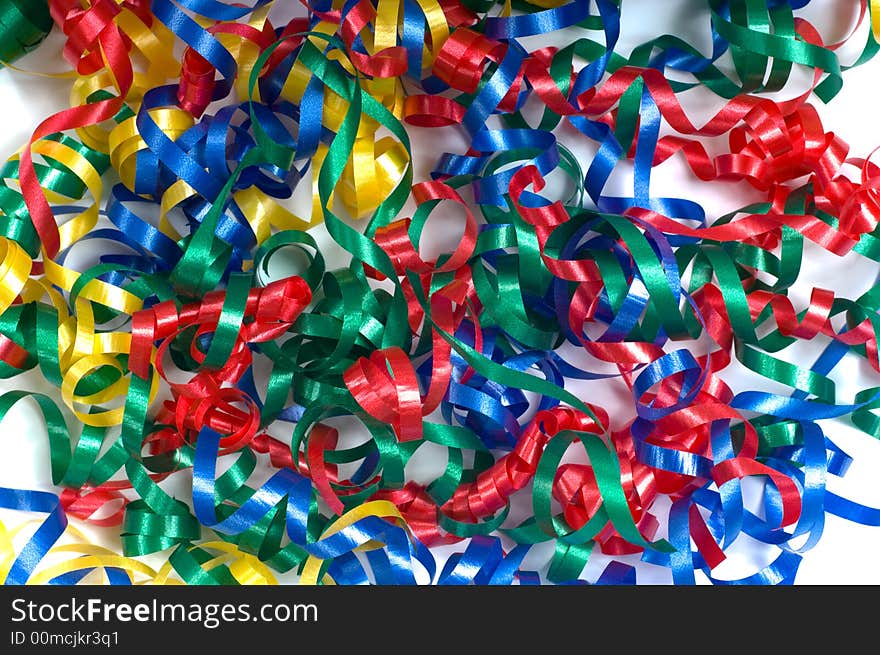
[0,0,880,584]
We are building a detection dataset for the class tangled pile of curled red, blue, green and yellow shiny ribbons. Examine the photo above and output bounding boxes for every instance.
[0,0,880,584]
